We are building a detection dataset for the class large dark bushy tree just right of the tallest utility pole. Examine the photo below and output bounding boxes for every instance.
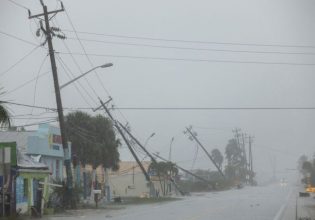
[65,111,120,170]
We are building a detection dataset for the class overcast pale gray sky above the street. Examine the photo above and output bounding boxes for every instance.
[0,0,315,181]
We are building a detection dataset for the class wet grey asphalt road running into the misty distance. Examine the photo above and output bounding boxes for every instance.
[45,184,296,220]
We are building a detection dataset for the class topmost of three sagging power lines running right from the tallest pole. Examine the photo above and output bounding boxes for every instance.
[62,29,315,48]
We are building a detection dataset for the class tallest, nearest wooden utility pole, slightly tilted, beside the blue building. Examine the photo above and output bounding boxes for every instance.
[29,0,75,207]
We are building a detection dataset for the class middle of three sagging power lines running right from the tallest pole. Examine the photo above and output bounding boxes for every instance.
[68,37,315,55]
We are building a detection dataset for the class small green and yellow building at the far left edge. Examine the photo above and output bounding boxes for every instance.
[0,142,49,216]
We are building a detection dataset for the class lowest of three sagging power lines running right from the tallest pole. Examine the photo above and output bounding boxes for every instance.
[57,52,315,66]
